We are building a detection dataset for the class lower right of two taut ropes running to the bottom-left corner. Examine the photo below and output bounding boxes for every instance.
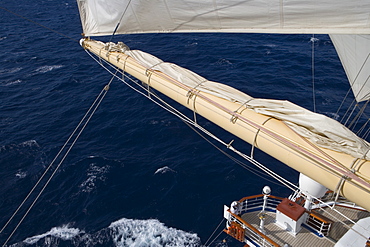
[3,77,114,246]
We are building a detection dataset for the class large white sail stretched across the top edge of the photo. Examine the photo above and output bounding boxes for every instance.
[77,0,370,36]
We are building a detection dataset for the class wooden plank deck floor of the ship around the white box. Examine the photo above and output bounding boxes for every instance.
[241,206,370,246]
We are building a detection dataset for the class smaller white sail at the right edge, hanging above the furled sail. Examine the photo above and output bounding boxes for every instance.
[330,34,370,102]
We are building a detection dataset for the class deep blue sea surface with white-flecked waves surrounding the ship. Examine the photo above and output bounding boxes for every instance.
[0,0,366,246]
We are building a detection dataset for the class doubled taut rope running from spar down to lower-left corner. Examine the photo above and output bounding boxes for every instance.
[1,77,114,246]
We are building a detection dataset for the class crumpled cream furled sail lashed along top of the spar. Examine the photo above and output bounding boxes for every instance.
[125,47,370,160]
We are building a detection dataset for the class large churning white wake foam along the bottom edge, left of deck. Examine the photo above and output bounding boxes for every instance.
[16,218,201,247]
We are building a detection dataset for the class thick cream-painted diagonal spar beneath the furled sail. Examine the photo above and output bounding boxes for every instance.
[81,39,370,210]
